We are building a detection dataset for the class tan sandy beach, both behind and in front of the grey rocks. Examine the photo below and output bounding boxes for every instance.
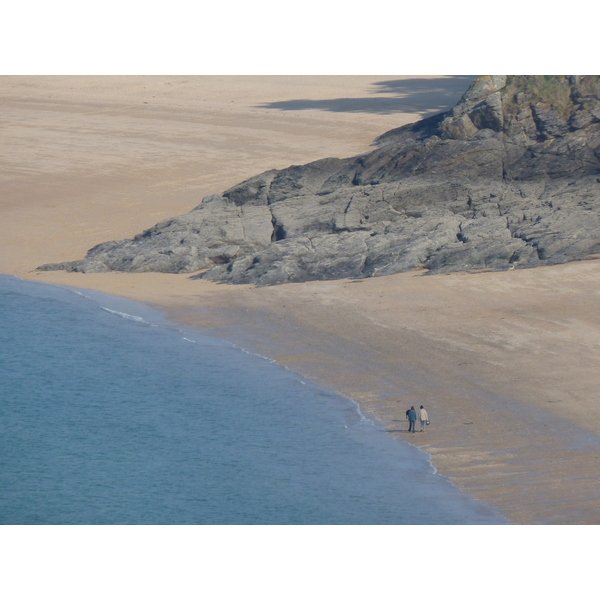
[0,76,600,523]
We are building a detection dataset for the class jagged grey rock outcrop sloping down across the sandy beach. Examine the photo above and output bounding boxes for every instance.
[40,76,600,285]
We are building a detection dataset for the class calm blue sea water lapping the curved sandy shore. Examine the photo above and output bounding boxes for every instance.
[0,275,506,524]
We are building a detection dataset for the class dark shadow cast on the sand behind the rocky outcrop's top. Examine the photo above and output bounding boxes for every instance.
[257,75,476,116]
